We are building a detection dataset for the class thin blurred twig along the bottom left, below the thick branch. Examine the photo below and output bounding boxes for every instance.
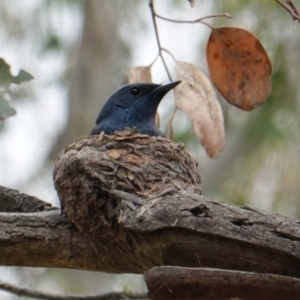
[0,281,149,300]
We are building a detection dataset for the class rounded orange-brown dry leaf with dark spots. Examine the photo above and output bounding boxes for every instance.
[206,27,272,111]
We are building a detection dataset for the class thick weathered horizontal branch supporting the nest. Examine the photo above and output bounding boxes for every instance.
[0,188,300,278]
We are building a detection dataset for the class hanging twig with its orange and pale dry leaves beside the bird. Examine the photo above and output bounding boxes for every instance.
[128,1,272,158]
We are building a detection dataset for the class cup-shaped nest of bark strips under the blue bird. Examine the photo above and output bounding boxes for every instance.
[54,130,201,235]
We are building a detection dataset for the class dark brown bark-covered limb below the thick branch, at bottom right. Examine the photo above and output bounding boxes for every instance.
[145,267,300,300]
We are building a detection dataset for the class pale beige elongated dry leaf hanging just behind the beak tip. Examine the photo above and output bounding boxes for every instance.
[174,61,225,158]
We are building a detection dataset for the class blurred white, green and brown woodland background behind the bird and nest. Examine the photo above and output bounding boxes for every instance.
[0,0,300,299]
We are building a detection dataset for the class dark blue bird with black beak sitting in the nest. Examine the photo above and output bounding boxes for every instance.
[90,81,181,137]
